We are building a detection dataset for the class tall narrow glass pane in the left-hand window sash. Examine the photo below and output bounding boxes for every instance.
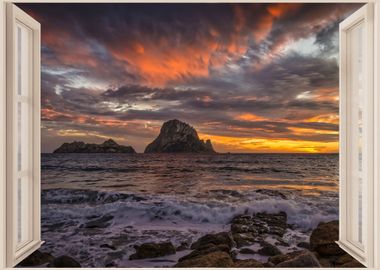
[15,24,33,247]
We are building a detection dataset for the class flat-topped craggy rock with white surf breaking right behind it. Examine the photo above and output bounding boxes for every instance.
[231,212,288,237]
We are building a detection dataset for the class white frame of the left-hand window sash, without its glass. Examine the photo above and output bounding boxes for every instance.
[6,3,42,265]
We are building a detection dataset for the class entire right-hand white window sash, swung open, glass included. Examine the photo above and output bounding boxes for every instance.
[338,4,374,267]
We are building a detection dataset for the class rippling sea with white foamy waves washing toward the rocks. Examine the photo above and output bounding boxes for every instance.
[41,154,339,267]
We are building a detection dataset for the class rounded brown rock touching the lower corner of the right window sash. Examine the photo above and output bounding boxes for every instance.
[310,220,345,256]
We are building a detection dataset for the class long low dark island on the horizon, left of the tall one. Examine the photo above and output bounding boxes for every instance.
[53,139,136,153]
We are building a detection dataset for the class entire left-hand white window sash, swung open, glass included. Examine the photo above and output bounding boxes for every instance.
[6,4,41,266]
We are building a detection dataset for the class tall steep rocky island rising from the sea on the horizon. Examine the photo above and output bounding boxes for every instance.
[145,119,215,153]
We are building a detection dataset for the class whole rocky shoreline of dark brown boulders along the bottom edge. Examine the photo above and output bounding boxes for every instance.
[18,212,364,268]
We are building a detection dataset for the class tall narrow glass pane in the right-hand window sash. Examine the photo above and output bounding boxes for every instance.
[347,23,365,246]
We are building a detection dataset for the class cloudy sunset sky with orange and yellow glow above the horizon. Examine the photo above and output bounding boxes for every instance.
[18,3,360,153]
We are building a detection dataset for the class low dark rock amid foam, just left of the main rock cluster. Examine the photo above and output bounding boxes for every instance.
[129,242,176,260]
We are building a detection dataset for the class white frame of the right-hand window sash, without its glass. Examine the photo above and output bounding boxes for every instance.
[337,3,374,266]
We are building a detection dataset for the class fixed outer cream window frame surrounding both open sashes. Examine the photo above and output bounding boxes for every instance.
[0,0,380,270]
